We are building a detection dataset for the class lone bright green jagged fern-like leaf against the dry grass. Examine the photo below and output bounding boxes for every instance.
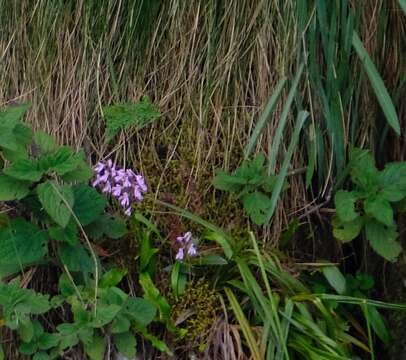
[103,96,161,141]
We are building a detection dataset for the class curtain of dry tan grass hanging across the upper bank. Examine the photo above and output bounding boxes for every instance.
[0,0,405,242]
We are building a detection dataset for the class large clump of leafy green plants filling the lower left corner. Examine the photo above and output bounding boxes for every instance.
[0,105,171,360]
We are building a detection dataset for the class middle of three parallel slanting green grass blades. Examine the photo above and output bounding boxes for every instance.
[268,64,304,174]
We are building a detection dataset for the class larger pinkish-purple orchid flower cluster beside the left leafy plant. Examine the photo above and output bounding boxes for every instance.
[92,159,147,216]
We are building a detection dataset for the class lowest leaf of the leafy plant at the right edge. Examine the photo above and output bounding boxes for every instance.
[365,221,402,261]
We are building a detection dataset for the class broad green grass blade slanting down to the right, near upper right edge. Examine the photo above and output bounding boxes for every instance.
[352,31,400,135]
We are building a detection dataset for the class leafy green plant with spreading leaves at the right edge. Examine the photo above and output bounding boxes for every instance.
[333,148,406,261]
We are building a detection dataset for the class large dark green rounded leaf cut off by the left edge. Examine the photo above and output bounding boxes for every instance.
[0,219,48,278]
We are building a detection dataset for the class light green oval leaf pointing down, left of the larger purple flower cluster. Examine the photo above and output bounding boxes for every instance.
[37,180,74,228]
